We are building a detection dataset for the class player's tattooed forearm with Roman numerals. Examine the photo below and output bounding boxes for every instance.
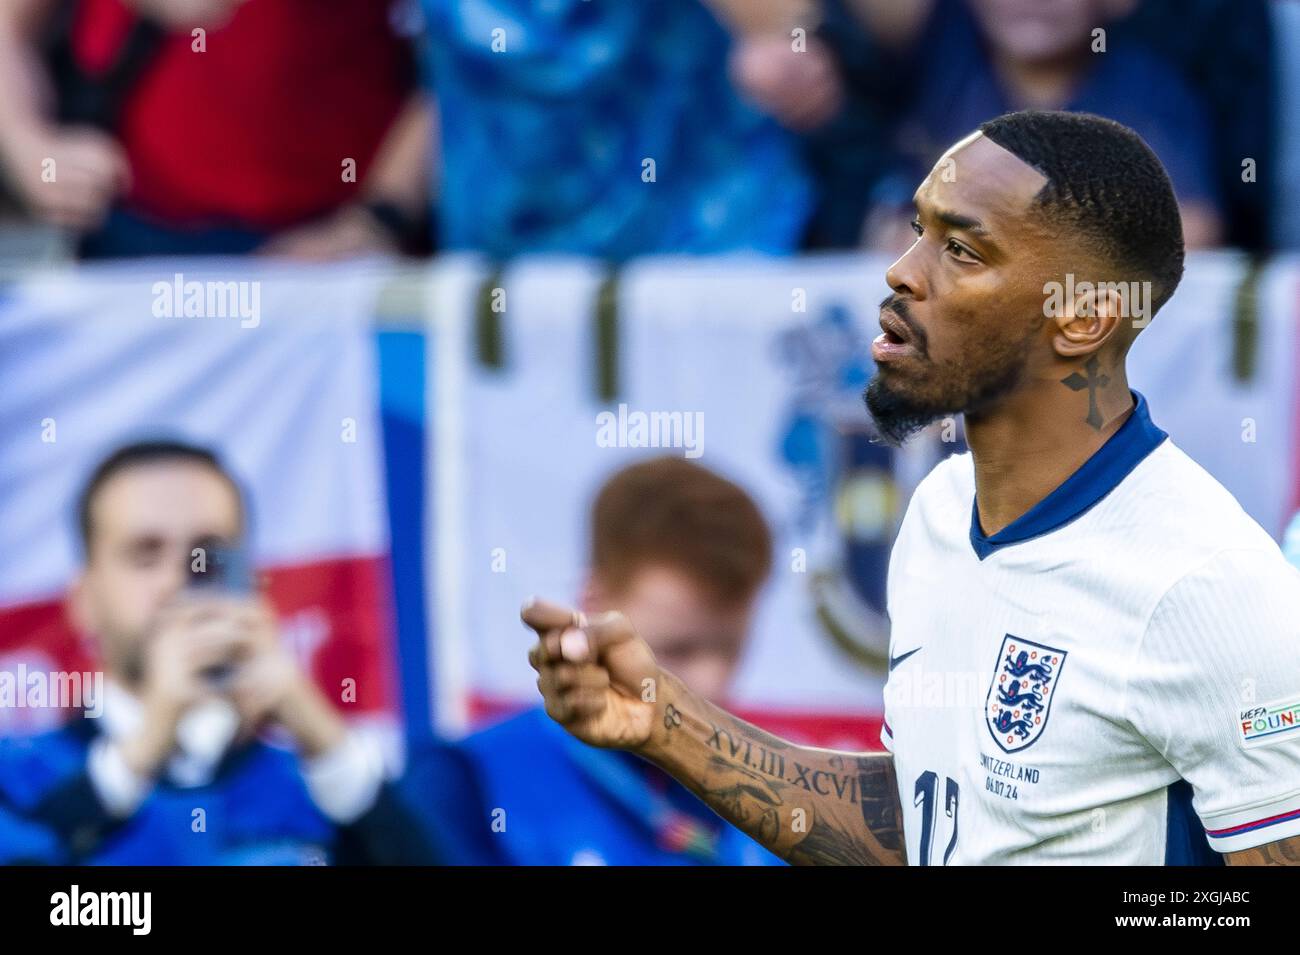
[640,673,905,865]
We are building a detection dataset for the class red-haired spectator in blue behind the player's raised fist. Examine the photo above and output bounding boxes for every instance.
[408,457,780,865]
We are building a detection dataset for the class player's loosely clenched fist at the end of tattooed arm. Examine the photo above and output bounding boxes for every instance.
[520,600,660,750]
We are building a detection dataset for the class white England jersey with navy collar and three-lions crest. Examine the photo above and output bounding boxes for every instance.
[881,394,1300,865]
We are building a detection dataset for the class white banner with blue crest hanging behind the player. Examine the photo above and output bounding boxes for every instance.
[430,250,1296,739]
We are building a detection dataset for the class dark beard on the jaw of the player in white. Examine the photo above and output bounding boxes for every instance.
[862,299,1034,447]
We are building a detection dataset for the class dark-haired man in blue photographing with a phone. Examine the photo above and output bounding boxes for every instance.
[0,443,434,865]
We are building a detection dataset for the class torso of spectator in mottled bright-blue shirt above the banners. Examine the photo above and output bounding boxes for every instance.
[424,0,811,259]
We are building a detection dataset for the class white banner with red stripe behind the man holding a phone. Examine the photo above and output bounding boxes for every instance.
[0,259,394,738]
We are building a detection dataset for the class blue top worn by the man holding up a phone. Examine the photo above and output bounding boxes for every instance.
[0,719,441,865]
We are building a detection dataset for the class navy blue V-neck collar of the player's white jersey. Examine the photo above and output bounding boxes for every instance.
[971,391,1169,560]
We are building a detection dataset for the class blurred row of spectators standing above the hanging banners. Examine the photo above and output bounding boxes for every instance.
[0,0,1300,260]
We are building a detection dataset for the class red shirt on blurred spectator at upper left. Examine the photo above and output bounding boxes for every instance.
[73,0,410,229]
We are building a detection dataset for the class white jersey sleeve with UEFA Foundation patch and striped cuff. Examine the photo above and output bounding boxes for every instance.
[1125,548,1300,852]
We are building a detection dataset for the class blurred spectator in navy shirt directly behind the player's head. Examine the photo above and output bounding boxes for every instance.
[742,0,1240,251]
